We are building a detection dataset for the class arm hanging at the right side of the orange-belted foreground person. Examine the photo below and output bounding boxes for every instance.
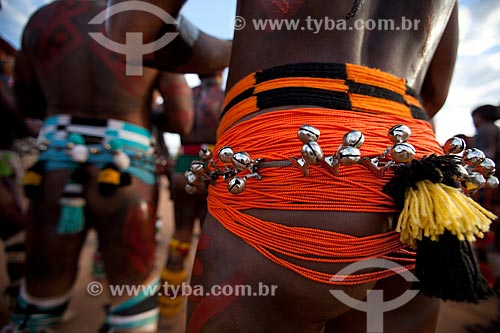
[420,4,458,118]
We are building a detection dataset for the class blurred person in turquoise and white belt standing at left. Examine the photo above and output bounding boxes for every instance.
[3,0,228,333]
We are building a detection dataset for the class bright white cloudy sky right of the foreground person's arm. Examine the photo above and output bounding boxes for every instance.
[434,0,500,143]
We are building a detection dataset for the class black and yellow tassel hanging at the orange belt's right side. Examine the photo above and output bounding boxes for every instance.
[384,155,493,303]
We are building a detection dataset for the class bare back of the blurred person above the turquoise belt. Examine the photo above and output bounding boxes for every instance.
[26,0,157,126]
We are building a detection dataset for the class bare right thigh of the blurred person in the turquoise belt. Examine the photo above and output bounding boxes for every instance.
[87,174,158,284]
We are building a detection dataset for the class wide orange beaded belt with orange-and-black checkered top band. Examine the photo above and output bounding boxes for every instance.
[191,64,442,284]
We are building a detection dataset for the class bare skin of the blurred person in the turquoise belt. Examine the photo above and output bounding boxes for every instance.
[15,0,201,324]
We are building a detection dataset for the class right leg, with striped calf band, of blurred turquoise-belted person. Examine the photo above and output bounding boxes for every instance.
[88,174,158,333]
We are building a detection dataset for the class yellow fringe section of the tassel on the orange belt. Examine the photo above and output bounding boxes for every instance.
[396,180,497,248]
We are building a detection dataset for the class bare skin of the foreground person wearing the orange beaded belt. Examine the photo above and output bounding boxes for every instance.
[109,0,458,333]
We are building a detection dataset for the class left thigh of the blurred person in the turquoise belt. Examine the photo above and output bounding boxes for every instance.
[26,171,86,297]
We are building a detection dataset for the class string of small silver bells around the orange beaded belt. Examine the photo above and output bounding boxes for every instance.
[185,124,499,194]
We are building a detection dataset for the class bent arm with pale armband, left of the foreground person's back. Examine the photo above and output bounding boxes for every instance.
[106,0,232,73]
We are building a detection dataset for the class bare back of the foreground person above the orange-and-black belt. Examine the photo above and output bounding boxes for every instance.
[228,0,455,92]
